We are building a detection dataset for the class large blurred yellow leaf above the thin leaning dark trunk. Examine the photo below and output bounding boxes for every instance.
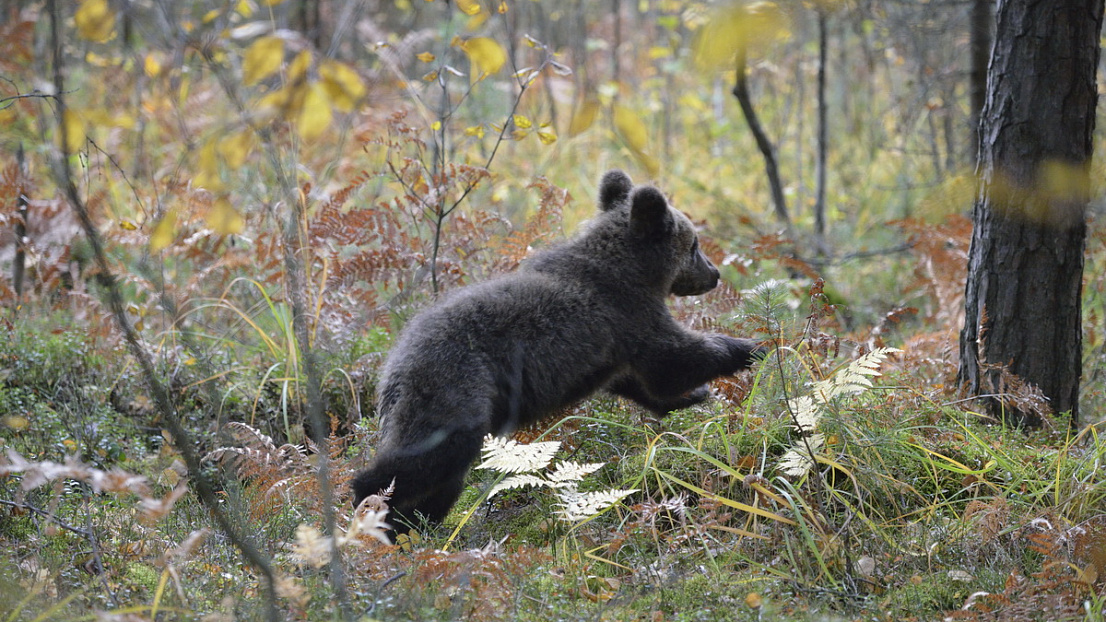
[692,1,789,69]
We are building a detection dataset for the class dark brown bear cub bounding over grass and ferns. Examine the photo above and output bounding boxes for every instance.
[353,169,765,528]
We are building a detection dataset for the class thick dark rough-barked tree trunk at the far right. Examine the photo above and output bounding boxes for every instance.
[959,0,1103,426]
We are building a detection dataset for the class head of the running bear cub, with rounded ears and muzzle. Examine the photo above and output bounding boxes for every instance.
[599,170,719,296]
